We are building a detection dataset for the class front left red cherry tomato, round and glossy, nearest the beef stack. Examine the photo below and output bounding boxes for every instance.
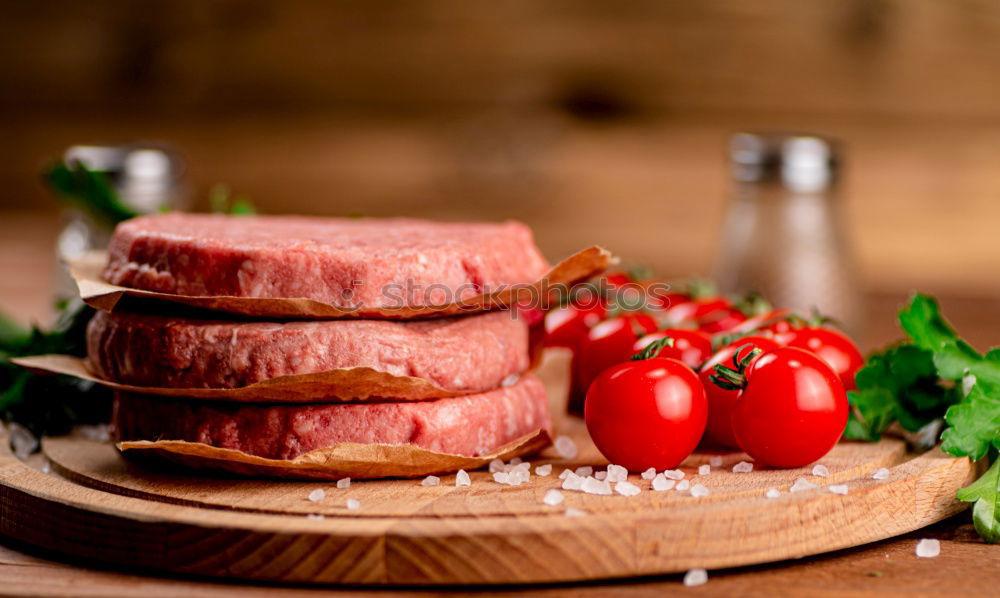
[584,357,708,471]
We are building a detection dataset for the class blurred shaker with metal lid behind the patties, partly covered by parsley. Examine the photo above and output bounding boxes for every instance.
[56,145,187,297]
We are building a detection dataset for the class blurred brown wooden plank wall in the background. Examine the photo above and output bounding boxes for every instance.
[0,0,1000,297]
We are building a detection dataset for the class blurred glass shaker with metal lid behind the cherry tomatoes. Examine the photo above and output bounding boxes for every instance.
[716,133,862,333]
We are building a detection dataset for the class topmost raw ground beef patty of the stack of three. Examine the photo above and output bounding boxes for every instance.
[103,213,548,309]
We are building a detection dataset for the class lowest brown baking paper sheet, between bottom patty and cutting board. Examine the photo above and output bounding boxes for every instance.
[116,429,551,480]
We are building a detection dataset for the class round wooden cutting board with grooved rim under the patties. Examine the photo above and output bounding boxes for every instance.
[0,354,980,584]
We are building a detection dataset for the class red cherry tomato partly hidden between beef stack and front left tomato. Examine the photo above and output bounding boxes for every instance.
[569,312,657,413]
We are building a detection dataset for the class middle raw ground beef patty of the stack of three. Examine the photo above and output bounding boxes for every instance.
[87,311,530,392]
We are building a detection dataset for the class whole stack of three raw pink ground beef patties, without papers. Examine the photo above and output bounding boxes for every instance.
[88,214,550,466]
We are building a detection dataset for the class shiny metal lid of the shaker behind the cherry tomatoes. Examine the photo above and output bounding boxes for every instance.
[729,132,840,192]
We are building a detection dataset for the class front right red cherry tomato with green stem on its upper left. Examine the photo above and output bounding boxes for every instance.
[732,347,848,467]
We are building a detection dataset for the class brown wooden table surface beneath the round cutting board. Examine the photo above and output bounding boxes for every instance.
[0,213,1000,598]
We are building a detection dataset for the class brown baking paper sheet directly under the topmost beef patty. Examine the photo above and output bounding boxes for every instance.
[69,245,618,319]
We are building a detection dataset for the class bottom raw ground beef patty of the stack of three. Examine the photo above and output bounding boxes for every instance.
[113,375,551,459]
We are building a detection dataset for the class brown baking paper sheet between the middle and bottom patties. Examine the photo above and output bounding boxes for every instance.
[10,355,476,403]
